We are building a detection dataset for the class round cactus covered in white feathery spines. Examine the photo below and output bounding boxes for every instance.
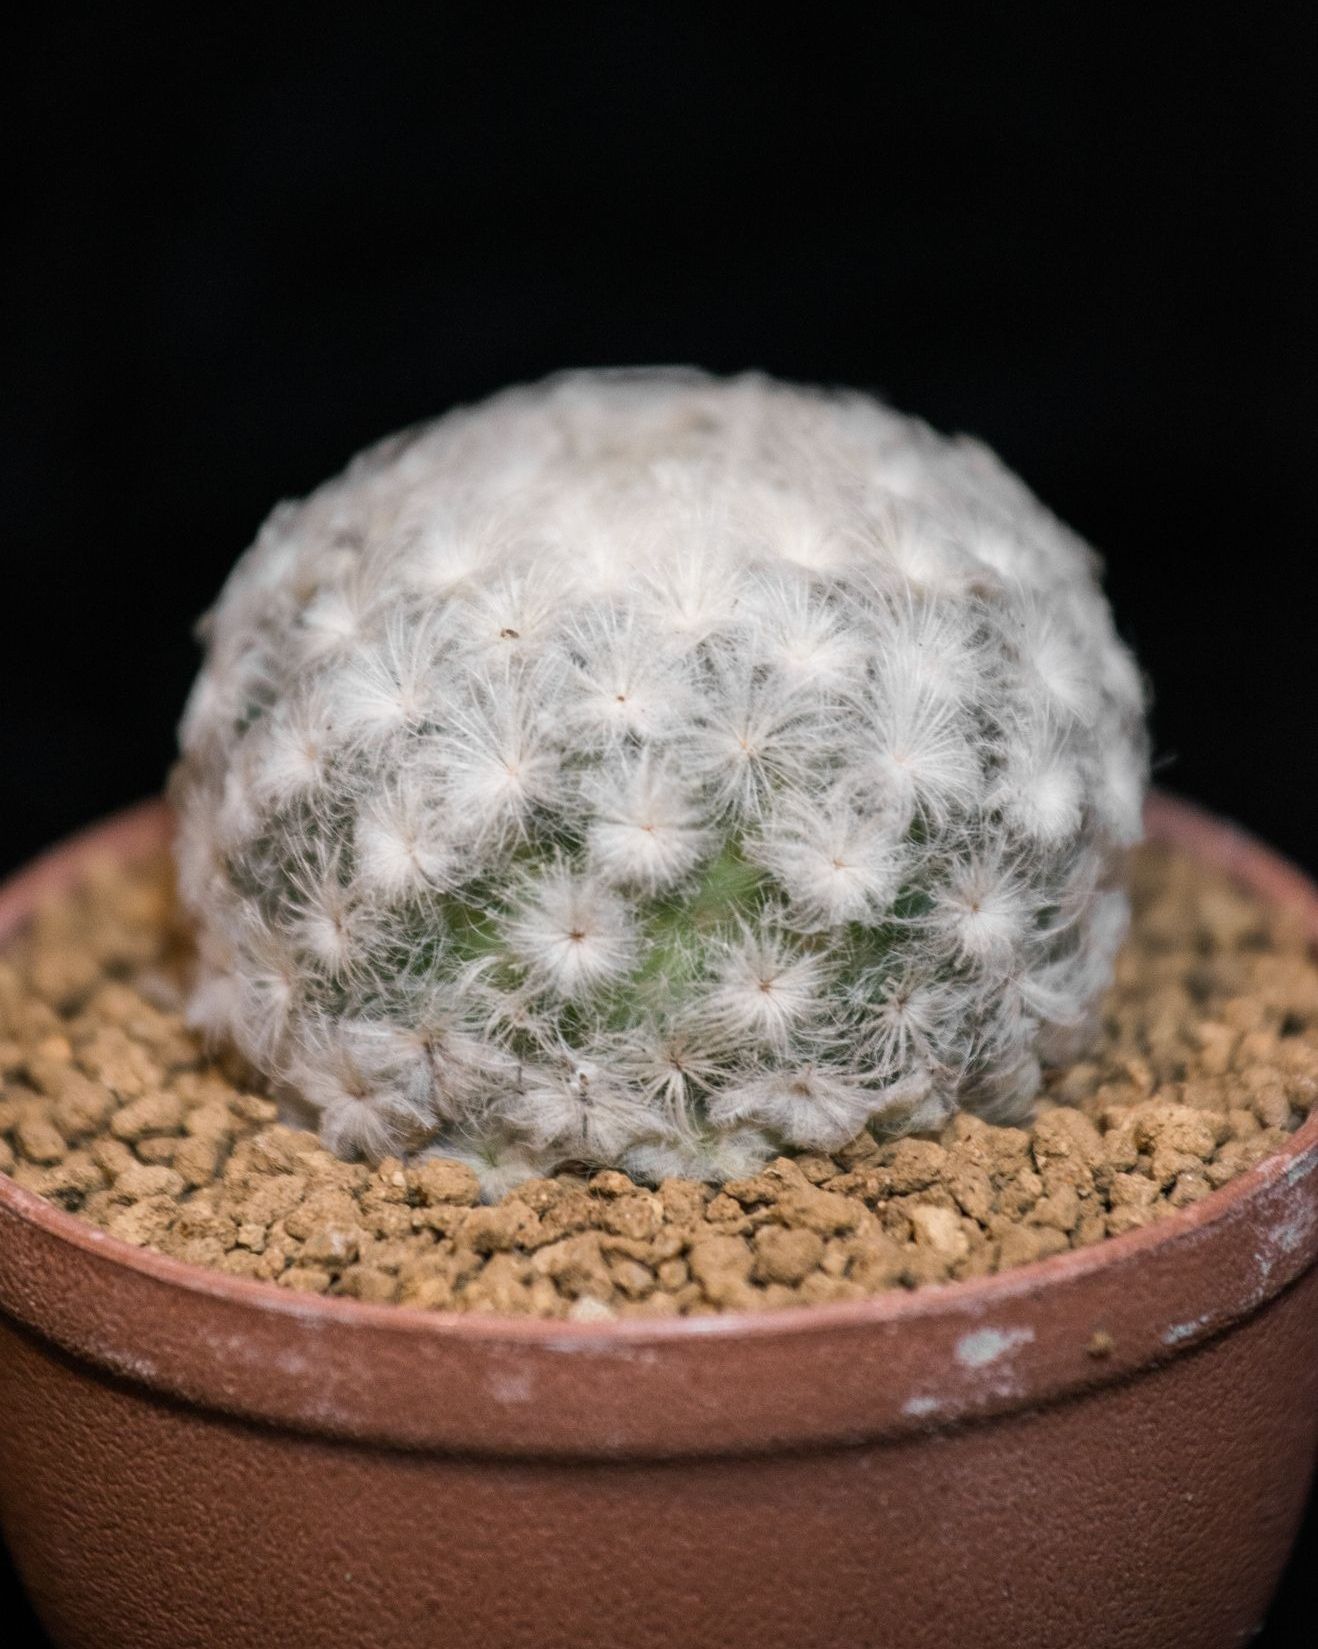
[175,371,1146,1186]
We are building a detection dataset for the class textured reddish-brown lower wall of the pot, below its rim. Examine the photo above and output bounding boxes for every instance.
[0,1271,1318,1649]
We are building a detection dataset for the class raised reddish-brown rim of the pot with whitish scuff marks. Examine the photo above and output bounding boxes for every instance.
[0,795,1318,1454]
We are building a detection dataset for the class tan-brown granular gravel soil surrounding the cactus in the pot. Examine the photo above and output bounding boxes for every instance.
[0,848,1318,1319]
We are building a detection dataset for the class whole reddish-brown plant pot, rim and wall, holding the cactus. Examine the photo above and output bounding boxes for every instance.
[0,800,1318,1649]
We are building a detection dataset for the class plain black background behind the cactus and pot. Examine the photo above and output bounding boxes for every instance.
[0,5,1318,1649]
